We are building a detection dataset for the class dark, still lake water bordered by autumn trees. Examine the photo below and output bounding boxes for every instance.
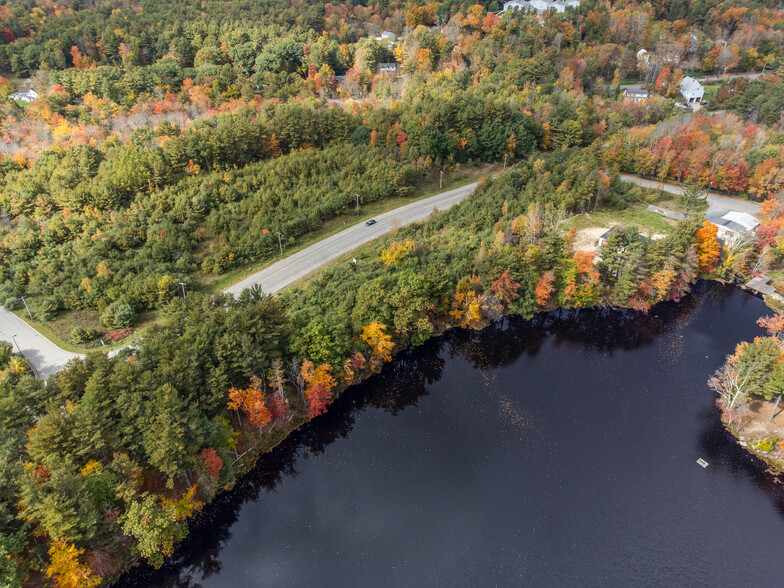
[119,283,784,588]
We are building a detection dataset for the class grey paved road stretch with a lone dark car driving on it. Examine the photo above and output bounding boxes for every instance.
[224,183,476,296]
